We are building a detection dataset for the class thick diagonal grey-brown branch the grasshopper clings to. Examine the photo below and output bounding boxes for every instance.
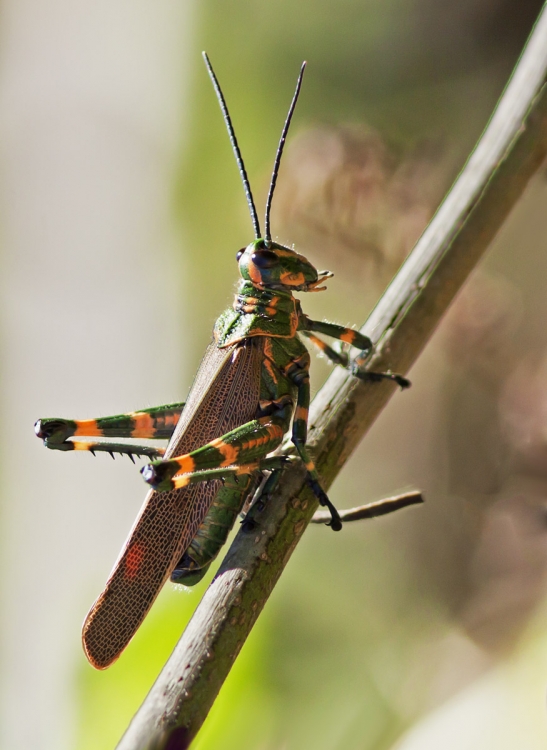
[118,7,547,750]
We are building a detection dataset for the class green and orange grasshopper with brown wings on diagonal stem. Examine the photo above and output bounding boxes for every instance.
[35,53,410,669]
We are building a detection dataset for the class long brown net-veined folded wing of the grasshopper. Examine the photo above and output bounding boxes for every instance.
[82,338,262,669]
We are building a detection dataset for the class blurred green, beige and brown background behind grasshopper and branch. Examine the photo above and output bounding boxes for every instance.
[0,0,547,750]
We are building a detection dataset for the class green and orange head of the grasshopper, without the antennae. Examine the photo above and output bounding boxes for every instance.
[236,239,332,292]
